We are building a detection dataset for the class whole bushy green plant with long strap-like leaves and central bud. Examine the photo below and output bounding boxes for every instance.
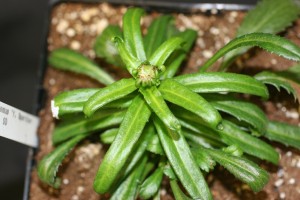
[38,0,300,200]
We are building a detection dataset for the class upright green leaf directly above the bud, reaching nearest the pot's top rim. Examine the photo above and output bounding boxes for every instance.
[123,8,146,62]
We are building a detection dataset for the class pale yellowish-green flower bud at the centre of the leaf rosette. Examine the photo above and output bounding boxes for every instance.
[136,64,164,87]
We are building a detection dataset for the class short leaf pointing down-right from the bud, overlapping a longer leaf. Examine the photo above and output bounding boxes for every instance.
[140,87,180,139]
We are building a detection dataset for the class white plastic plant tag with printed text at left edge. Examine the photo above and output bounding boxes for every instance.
[0,101,39,147]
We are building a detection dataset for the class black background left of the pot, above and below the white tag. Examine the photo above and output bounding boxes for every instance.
[0,0,256,200]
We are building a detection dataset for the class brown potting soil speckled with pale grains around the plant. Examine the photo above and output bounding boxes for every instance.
[30,3,300,200]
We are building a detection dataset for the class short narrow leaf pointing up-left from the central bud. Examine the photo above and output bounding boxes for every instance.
[113,37,142,76]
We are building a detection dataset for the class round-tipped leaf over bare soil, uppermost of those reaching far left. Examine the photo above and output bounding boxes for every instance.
[48,48,114,85]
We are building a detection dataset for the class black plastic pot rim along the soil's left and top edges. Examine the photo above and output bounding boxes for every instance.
[23,0,257,200]
